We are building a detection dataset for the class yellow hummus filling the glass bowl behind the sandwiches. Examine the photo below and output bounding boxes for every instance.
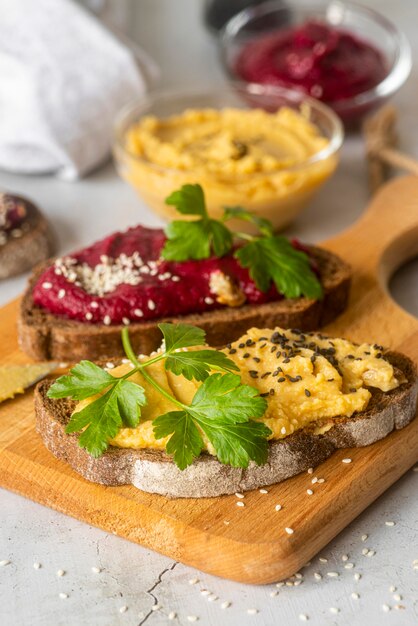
[117,107,337,232]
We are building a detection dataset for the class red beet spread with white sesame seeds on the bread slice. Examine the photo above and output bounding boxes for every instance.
[33,226,316,324]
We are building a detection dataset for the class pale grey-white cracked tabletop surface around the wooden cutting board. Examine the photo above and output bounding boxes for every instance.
[0,0,418,626]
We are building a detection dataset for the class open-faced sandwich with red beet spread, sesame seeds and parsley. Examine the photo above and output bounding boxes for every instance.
[18,185,350,361]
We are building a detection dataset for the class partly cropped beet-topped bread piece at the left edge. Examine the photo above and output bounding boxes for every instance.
[0,193,52,279]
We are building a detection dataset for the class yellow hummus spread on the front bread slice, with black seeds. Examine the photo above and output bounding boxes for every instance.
[72,328,403,453]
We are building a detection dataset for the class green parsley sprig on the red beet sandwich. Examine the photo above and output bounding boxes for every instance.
[162,185,323,300]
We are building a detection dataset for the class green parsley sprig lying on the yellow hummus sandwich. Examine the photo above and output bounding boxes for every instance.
[48,324,271,470]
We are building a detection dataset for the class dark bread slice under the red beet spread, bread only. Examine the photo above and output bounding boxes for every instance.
[18,246,351,361]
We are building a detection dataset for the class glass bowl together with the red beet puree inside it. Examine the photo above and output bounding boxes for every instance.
[221,0,411,128]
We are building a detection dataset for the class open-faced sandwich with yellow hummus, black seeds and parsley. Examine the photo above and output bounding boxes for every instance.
[35,324,418,497]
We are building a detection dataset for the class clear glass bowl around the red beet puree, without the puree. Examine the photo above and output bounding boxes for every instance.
[220,0,411,126]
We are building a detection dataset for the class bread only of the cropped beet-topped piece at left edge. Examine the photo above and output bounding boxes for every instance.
[0,196,53,280]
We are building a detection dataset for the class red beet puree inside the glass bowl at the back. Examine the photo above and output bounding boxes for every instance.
[235,21,387,103]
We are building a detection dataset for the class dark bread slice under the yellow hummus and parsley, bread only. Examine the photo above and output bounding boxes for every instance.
[35,352,418,498]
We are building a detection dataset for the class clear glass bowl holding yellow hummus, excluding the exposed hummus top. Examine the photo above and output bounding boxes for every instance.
[113,83,343,232]
